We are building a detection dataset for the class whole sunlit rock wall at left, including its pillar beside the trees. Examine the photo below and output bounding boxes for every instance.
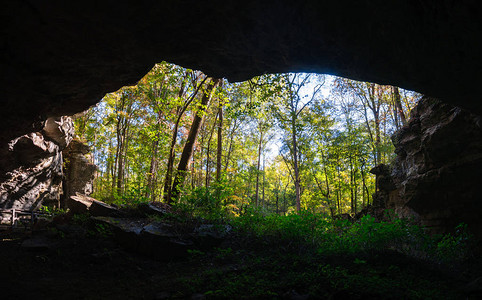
[0,117,97,210]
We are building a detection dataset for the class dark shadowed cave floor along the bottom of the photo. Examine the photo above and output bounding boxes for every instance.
[0,226,473,299]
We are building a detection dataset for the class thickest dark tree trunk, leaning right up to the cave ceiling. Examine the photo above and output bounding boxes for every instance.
[168,79,221,203]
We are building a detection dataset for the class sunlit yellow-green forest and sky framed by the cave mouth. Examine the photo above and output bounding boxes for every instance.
[74,62,420,216]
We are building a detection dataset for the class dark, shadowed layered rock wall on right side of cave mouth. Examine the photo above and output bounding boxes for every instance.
[382,97,482,237]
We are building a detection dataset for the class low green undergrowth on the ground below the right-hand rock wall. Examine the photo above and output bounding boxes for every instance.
[231,209,472,263]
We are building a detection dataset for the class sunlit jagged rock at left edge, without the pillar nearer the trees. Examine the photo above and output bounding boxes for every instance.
[0,117,74,210]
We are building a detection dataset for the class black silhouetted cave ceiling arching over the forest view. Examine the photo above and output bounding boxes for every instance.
[0,0,482,144]
